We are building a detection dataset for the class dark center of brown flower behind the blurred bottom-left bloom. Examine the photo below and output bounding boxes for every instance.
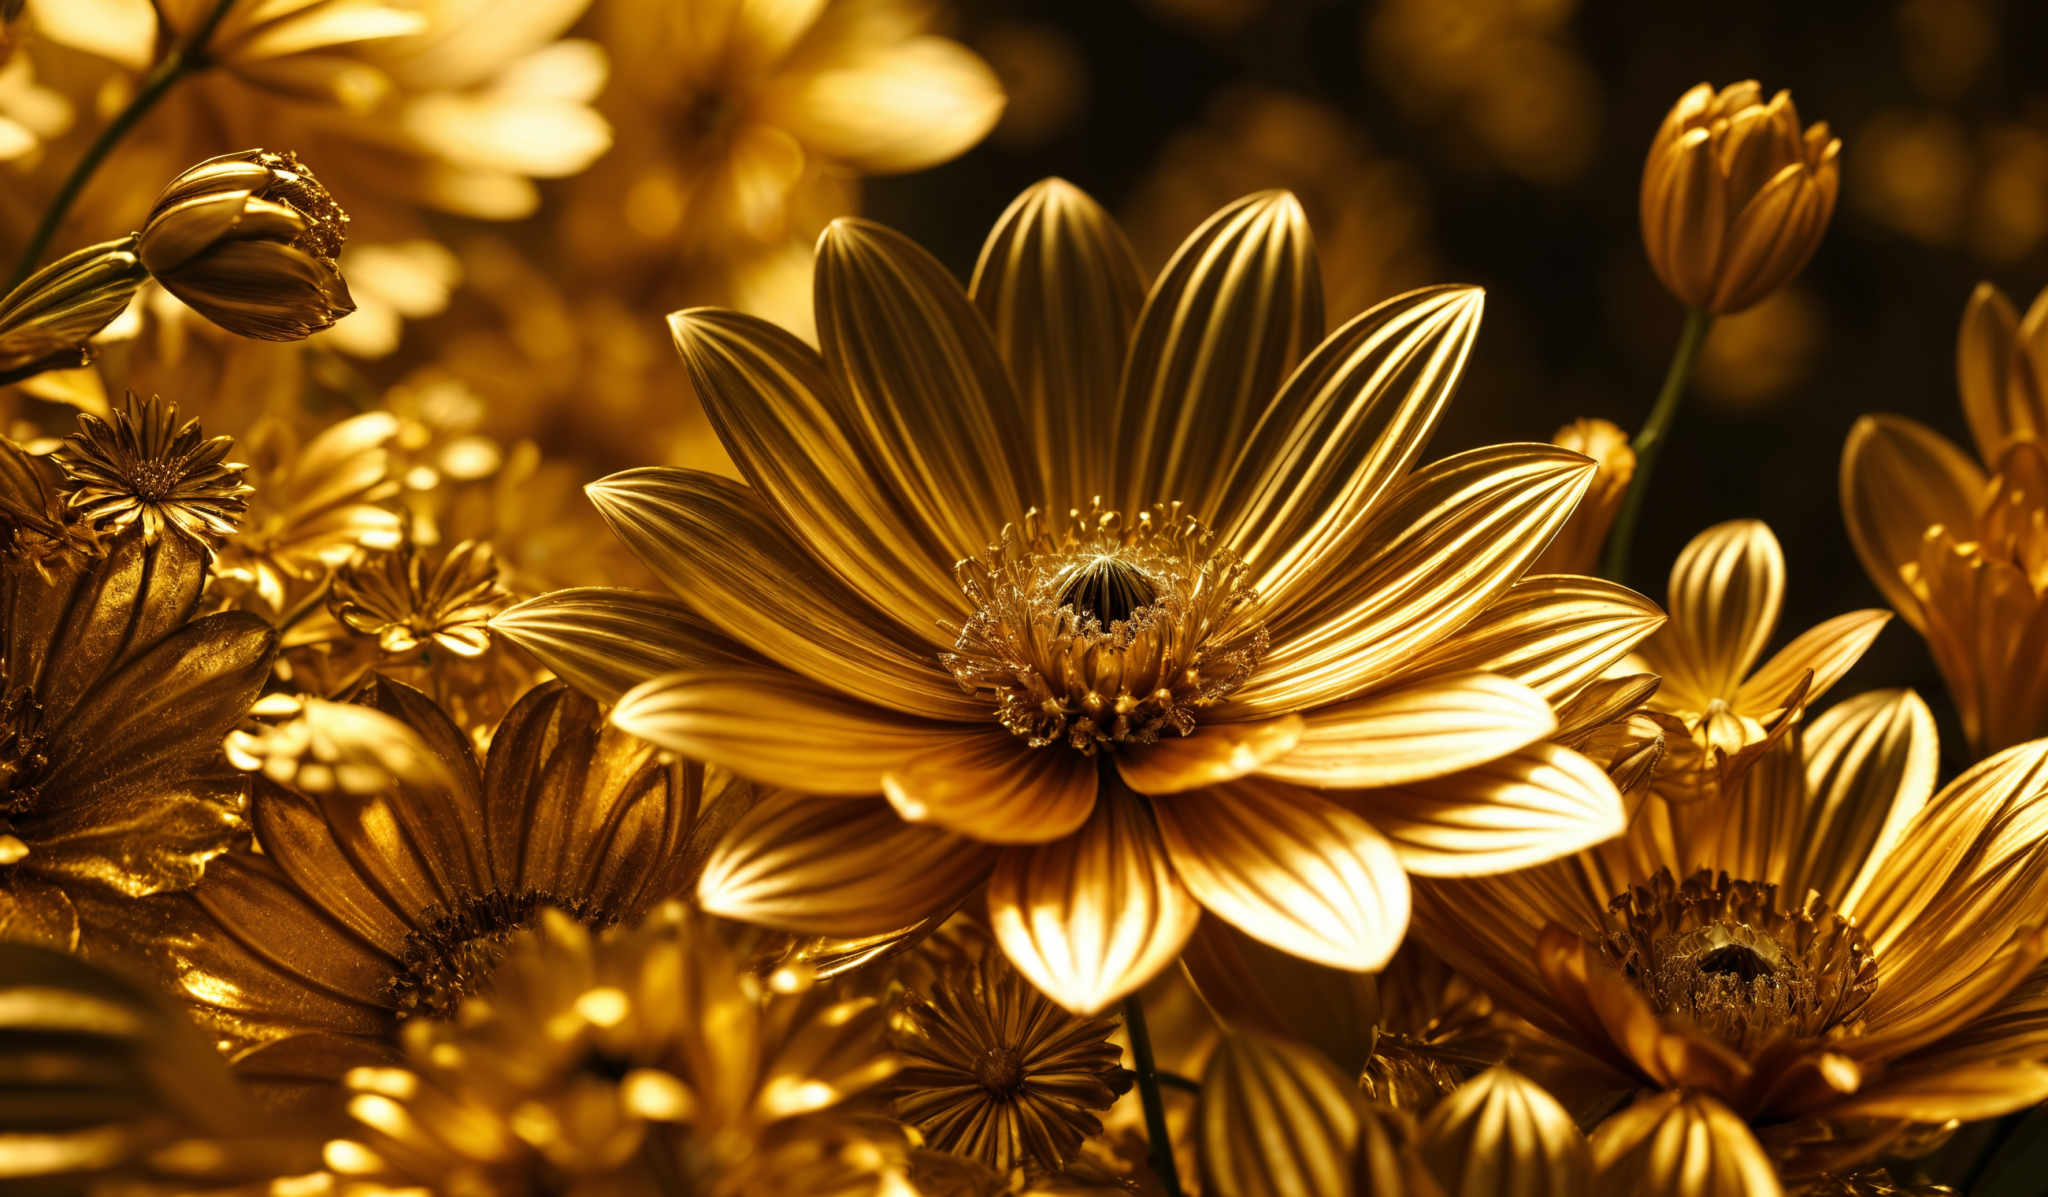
[383,890,612,1019]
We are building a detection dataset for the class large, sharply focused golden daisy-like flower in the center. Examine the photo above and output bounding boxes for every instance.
[494,180,1657,1013]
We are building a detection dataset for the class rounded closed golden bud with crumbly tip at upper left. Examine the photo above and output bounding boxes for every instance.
[139,150,356,340]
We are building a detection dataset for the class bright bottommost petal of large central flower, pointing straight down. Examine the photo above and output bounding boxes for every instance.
[989,787,1202,1015]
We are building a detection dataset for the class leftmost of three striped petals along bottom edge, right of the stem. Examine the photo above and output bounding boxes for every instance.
[1194,1029,1360,1197]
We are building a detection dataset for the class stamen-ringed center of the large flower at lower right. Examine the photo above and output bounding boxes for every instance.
[1602,871,1878,1051]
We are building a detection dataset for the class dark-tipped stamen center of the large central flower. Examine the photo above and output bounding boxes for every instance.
[940,502,1266,752]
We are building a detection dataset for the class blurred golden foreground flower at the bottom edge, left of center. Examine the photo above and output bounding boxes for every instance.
[326,902,901,1197]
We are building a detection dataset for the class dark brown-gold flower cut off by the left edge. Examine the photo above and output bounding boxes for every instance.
[0,514,276,949]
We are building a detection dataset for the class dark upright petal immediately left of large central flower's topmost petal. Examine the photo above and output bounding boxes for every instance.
[813,219,1036,560]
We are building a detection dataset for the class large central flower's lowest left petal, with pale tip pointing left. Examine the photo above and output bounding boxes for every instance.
[696,793,995,935]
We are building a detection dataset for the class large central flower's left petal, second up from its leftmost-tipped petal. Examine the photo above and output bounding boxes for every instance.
[588,467,970,719]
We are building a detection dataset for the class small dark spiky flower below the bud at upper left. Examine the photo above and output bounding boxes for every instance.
[55,391,252,551]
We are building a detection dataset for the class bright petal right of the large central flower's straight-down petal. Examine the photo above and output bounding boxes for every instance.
[1153,781,1409,972]
